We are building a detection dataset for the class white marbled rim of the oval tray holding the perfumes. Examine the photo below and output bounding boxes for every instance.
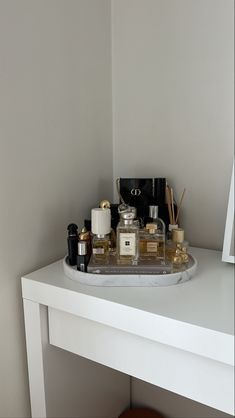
[63,255,197,287]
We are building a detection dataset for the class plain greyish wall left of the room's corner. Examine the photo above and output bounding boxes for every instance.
[0,0,112,418]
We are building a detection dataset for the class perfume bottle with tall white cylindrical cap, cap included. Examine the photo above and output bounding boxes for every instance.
[91,208,111,264]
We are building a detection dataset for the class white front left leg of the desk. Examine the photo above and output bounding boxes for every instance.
[23,299,46,418]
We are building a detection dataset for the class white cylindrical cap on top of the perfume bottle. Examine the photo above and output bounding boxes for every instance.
[91,208,111,235]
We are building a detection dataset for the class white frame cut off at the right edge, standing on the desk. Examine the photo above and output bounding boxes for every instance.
[222,163,235,263]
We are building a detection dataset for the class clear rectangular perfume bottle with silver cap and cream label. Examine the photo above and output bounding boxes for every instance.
[117,205,139,264]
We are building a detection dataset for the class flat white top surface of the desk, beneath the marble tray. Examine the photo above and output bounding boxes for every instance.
[23,248,234,335]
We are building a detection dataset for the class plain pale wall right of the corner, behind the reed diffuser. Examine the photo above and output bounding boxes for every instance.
[112,0,234,249]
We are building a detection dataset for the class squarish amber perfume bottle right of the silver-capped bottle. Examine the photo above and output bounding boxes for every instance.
[139,219,165,261]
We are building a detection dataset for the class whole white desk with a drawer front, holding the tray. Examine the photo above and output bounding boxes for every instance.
[22,248,234,418]
